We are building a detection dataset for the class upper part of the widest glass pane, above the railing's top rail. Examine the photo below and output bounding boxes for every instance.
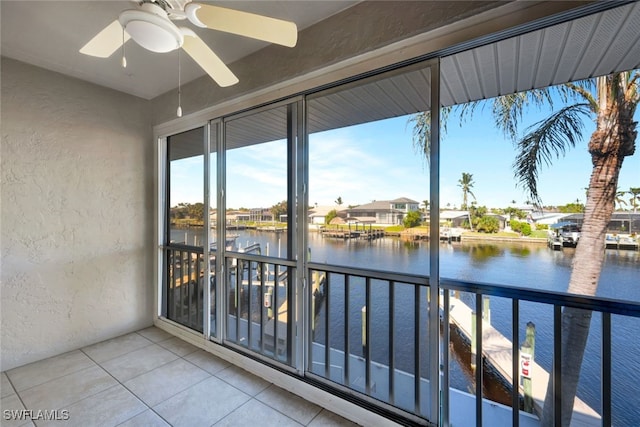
[308,68,431,274]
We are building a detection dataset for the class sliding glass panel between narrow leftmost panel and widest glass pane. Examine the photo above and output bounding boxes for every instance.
[221,104,296,365]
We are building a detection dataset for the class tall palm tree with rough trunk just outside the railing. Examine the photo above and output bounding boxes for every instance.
[411,70,640,426]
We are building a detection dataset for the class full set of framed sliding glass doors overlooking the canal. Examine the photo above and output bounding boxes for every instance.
[163,62,446,419]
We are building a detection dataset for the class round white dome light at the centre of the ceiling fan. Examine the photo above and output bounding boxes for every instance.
[119,3,184,53]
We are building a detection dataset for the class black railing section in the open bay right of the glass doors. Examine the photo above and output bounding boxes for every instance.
[440,279,640,426]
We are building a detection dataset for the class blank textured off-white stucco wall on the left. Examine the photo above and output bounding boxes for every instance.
[0,58,154,370]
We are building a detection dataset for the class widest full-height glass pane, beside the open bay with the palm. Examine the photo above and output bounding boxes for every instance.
[307,65,438,418]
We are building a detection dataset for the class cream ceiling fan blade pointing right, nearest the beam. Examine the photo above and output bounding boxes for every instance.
[185,3,298,47]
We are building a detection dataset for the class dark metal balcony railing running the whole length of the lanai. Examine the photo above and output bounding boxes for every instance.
[165,249,640,426]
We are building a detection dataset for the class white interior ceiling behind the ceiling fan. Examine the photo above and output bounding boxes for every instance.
[0,0,358,99]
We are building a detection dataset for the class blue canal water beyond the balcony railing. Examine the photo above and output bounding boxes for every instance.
[171,230,640,426]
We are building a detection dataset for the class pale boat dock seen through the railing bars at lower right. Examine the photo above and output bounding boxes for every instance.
[440,295,602,426]
